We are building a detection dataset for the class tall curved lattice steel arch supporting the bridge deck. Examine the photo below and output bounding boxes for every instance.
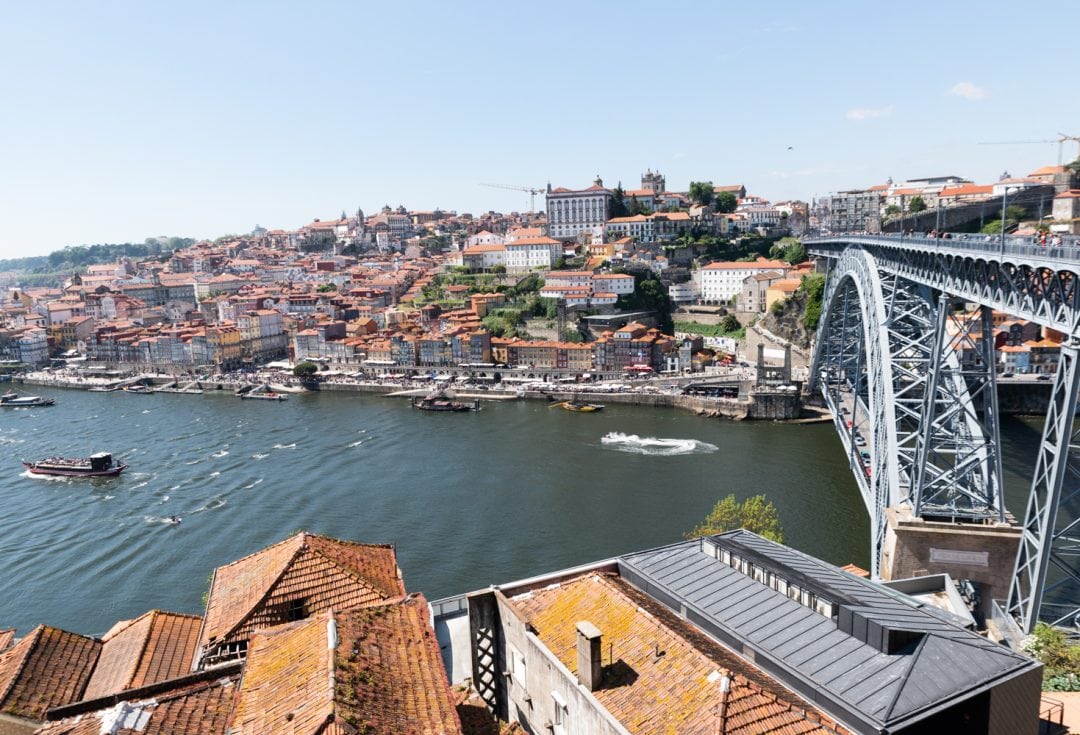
[810,246,1004,576]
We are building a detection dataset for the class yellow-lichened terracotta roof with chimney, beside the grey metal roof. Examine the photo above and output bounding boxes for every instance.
[512,574,847,735]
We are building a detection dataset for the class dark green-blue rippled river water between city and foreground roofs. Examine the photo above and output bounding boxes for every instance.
[0,386,1038,635]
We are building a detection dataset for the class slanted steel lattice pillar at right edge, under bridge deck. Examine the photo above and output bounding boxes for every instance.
[1007,337,1080,634]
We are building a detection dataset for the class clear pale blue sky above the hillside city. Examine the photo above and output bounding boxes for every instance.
[0,0,1080,257]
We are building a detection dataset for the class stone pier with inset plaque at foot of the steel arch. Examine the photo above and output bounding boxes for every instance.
[881,505,1023,616]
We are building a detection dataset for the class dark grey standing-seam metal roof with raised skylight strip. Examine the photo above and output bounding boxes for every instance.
[619,531,1039,732]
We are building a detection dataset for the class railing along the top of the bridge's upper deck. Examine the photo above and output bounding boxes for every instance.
[802,234,1080,263]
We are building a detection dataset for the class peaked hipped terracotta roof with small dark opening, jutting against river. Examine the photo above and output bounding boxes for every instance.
[199,532,405,653]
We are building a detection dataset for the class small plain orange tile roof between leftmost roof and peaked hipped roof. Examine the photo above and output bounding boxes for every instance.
[82,610,202,699]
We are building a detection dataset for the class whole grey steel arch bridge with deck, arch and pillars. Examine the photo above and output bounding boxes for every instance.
[804,235,1080,631]
